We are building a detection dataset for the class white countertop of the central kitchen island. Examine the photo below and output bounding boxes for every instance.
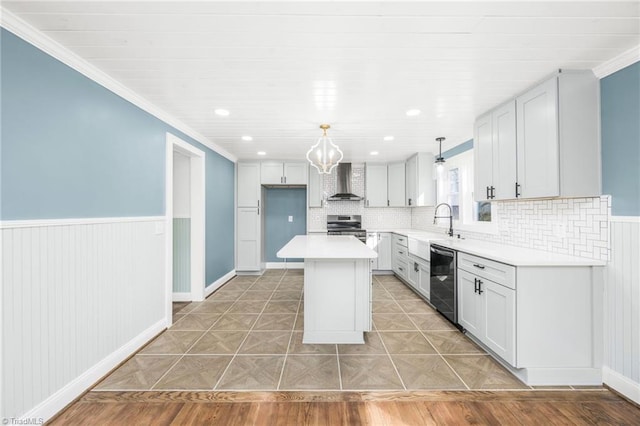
[277,235,378,259]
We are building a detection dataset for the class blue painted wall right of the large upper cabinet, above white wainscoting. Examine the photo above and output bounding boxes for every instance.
[600,62,640,216]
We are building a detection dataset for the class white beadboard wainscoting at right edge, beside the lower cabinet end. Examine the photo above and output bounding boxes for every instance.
[603,216,640,403]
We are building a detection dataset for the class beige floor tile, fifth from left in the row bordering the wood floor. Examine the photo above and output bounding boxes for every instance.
[338,355,403,390]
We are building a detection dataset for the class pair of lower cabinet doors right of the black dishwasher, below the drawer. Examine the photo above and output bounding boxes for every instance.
[458,269,516,365]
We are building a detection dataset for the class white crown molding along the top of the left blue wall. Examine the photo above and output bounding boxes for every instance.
[0,7,238,163]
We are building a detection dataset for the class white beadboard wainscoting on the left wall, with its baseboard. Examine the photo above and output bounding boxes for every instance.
[0,217,166,420]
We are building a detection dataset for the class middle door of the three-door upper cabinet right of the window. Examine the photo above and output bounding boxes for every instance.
[491,101,517,200]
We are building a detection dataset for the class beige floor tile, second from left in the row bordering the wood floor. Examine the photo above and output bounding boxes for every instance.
[153,355,232,390]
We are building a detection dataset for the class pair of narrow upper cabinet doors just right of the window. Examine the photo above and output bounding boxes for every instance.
[473,100,517,201]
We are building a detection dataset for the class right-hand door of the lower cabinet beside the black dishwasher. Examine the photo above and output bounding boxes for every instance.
[484,280,516,365]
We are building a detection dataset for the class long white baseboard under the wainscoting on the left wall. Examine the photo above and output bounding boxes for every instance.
[20,318,166,421]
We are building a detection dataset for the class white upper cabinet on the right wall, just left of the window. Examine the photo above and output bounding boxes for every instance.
[405,152,436,207]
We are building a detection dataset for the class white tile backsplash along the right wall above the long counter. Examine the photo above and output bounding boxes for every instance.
[411,196,611,260]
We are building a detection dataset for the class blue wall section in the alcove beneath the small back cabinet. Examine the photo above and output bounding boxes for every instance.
[264,188,307,262]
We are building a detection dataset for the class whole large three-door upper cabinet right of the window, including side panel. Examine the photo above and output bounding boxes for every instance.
[474,71,601,201]
